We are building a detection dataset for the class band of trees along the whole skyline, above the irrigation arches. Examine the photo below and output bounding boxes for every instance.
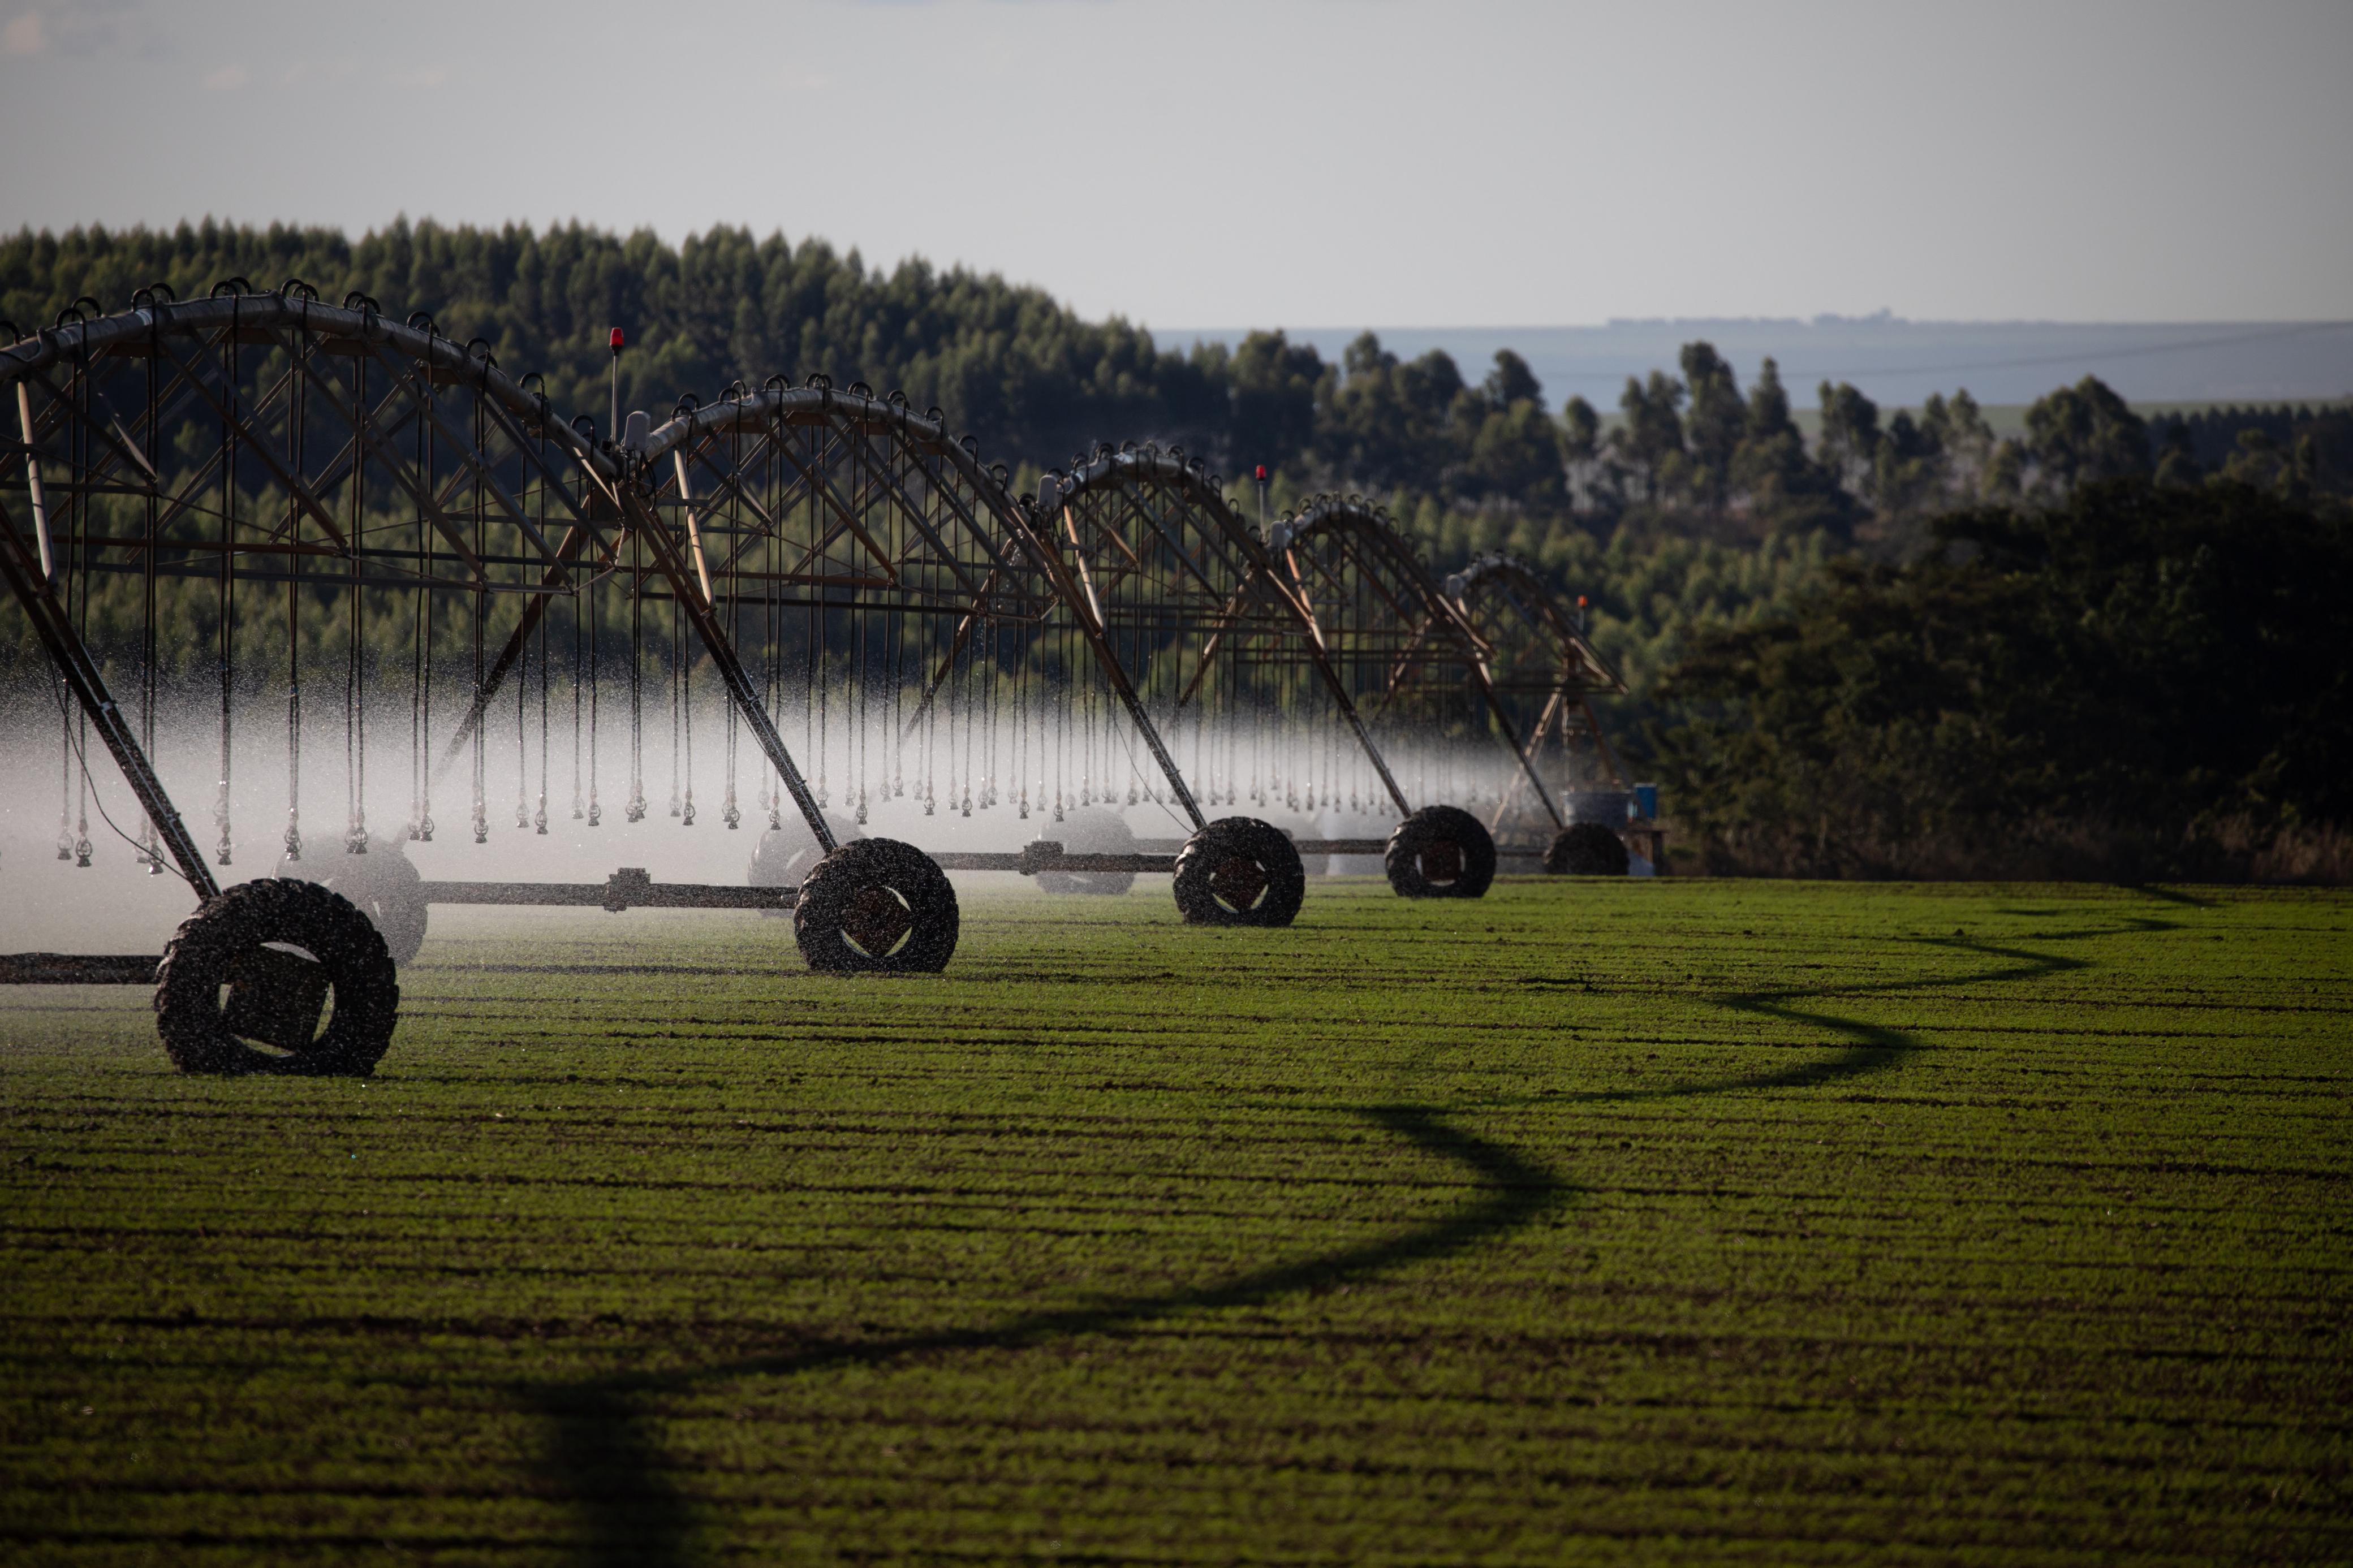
[0,221,2353,538]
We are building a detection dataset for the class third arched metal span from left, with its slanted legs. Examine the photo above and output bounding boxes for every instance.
[1035,442,1414,823]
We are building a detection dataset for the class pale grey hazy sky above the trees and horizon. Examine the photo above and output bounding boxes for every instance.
[0,0,2353,329]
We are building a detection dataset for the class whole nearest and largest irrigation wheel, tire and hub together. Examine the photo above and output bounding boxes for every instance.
[156,877,400,1077]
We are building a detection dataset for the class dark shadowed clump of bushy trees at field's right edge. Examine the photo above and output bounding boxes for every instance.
[1657,482,2353,875]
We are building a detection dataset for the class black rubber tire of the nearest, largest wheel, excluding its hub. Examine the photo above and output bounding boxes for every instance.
[156,877,400,1079]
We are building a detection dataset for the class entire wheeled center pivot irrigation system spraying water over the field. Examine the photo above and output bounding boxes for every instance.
[0,280,1619,1072]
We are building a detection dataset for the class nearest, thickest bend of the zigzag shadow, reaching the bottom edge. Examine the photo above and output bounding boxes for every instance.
[532,1105,1570,1568]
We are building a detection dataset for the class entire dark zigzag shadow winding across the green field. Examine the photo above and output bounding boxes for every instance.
[529,919,2136,1568]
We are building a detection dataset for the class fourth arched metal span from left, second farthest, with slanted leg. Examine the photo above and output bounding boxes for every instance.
[1268,496,1565,827]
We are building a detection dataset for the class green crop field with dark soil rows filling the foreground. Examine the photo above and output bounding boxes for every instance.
[0,879,2353,1568]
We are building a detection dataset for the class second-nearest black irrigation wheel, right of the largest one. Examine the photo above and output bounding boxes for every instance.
[793,839,958,975]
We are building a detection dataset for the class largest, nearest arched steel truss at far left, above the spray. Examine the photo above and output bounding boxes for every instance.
[0,284,619,593]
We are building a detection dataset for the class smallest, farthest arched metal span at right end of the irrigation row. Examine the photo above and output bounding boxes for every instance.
[1445,555,1626,827]
